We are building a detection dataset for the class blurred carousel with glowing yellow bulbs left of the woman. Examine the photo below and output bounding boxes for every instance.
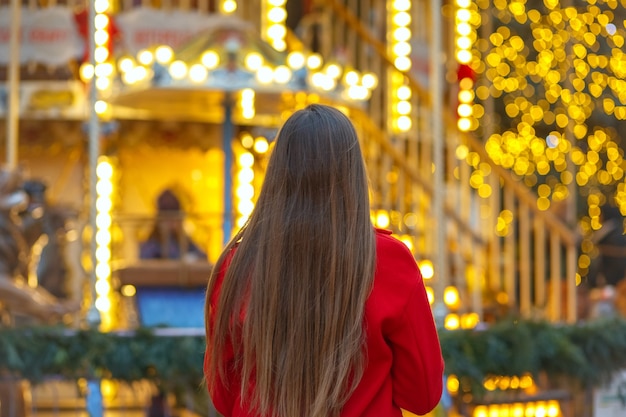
[3,2,377,330]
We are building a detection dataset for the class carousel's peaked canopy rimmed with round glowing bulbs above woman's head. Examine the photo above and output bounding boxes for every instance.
[108,16,369,126]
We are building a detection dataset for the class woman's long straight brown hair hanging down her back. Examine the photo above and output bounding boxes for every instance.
[205,105,375,417]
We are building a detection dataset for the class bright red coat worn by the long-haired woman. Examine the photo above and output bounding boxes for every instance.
[204,230,444,417]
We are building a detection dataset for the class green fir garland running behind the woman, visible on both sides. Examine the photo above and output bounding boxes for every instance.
[0,318,626,394]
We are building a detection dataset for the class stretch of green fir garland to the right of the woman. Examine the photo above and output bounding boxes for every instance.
[440,318,626,393]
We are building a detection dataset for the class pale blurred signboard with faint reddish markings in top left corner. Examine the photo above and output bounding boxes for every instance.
[0,6,85,66]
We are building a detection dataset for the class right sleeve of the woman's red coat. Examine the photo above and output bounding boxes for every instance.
[387,261,444,415]
